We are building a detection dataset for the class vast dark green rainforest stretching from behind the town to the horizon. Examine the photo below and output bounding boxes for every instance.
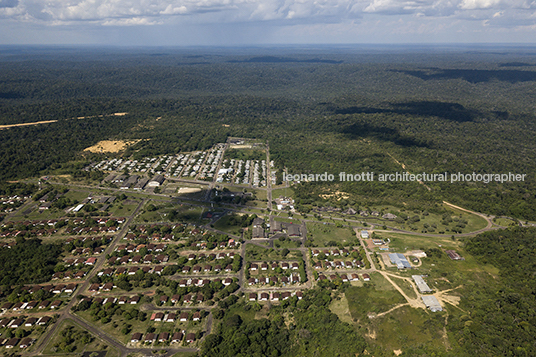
[0,47,536,220]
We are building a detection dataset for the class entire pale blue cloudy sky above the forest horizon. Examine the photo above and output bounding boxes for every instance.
[0,0,536,46]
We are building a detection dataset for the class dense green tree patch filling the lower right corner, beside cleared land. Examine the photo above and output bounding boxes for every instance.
[447,227,536,356]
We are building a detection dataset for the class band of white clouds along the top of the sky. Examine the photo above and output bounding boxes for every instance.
[0,0,536,38]
